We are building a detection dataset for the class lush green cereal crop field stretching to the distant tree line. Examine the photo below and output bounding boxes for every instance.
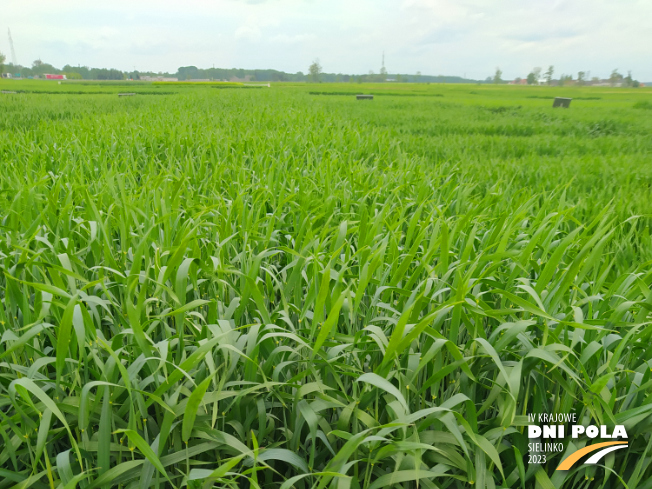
[0,82,652,489]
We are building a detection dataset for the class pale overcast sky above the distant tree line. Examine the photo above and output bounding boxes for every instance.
[0,0,652,81]
